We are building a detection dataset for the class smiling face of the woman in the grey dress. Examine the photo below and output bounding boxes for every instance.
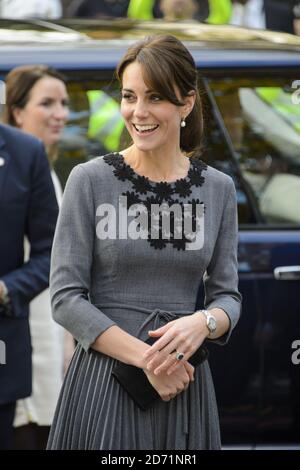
[121,62,188,153]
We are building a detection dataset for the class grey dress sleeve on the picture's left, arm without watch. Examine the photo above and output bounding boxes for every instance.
[50,165,115,351]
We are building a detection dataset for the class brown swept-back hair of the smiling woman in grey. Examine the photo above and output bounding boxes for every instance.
[116,36,203,153]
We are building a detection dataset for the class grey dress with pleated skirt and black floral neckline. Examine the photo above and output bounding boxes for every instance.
[48,153,241,450]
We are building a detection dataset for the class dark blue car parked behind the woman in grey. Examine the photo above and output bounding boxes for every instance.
[0,20,300,448]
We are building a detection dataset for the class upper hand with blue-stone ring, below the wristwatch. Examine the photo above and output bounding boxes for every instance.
[143,312,209,375]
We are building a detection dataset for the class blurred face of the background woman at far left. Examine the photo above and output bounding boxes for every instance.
[14,76,69,147]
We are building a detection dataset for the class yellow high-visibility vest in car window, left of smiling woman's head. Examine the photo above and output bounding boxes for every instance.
[87,90,124,152]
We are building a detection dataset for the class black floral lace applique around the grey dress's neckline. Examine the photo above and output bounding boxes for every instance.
[103,153,207,250]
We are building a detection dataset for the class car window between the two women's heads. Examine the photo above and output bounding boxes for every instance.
[55,76,128,186]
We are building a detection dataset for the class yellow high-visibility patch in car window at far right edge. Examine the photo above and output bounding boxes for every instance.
[255,87,300,132]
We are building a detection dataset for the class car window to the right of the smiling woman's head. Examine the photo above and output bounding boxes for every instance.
[209,78,300,225]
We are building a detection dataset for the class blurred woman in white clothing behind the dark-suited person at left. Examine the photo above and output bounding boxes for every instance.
[4,65,74,449]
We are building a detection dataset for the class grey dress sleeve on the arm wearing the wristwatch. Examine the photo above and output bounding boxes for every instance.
[203,176,241,345]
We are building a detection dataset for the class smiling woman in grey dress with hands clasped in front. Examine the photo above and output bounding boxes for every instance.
[48,36,241,450]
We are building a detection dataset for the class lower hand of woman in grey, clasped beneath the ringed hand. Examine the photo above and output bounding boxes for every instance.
[144,361,194,401]
